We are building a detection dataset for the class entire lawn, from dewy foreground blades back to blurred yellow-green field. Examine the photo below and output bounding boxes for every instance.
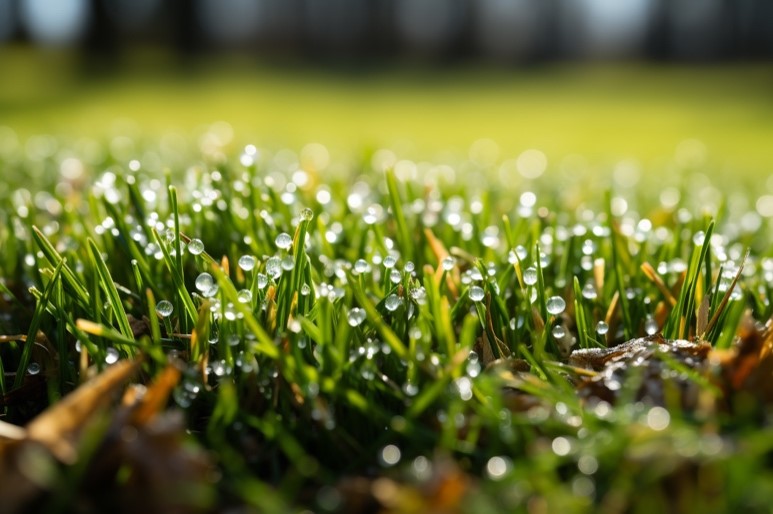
[0,55,773,513]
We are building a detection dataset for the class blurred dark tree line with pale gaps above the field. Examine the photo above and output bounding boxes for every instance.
[0,0,773,64]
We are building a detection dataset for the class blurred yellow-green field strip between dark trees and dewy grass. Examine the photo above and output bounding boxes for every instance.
[0,48,773,179]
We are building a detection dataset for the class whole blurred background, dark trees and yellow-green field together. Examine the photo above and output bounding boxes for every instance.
[0,0,773,189]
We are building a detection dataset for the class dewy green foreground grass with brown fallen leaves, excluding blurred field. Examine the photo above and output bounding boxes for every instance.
[0,126,773,512]
